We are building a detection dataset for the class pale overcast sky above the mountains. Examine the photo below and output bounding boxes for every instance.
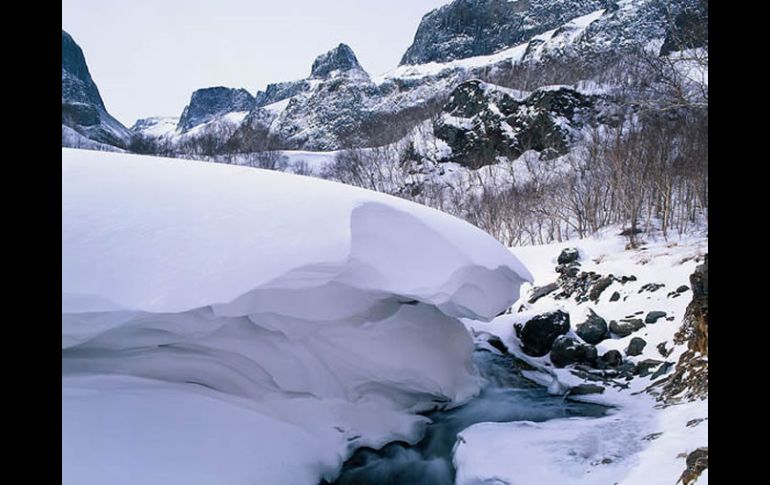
[62,0,450,126]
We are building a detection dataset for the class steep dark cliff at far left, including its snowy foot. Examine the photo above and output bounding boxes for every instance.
[61,30,131,148]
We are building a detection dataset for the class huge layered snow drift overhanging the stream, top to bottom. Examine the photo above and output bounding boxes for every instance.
[62,149,531,485]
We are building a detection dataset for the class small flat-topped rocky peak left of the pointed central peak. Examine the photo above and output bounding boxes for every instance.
[178,86,254,132]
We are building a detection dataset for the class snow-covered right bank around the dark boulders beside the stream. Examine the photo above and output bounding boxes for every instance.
[454,228,708,485]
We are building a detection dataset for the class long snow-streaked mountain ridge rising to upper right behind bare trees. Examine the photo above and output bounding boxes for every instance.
[124,0,708,156]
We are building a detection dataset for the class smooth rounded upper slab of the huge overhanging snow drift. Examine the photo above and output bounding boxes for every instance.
[62,149,531,319]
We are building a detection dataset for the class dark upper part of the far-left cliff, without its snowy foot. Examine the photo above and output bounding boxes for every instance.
[61,30,105,109]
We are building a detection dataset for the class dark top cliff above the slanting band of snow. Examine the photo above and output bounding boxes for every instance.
[401,0,607,64]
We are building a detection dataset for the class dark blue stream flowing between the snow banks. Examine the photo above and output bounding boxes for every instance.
[321,350,607,485]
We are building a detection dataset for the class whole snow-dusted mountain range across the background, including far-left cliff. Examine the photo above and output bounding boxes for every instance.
[62,0,708,161]
